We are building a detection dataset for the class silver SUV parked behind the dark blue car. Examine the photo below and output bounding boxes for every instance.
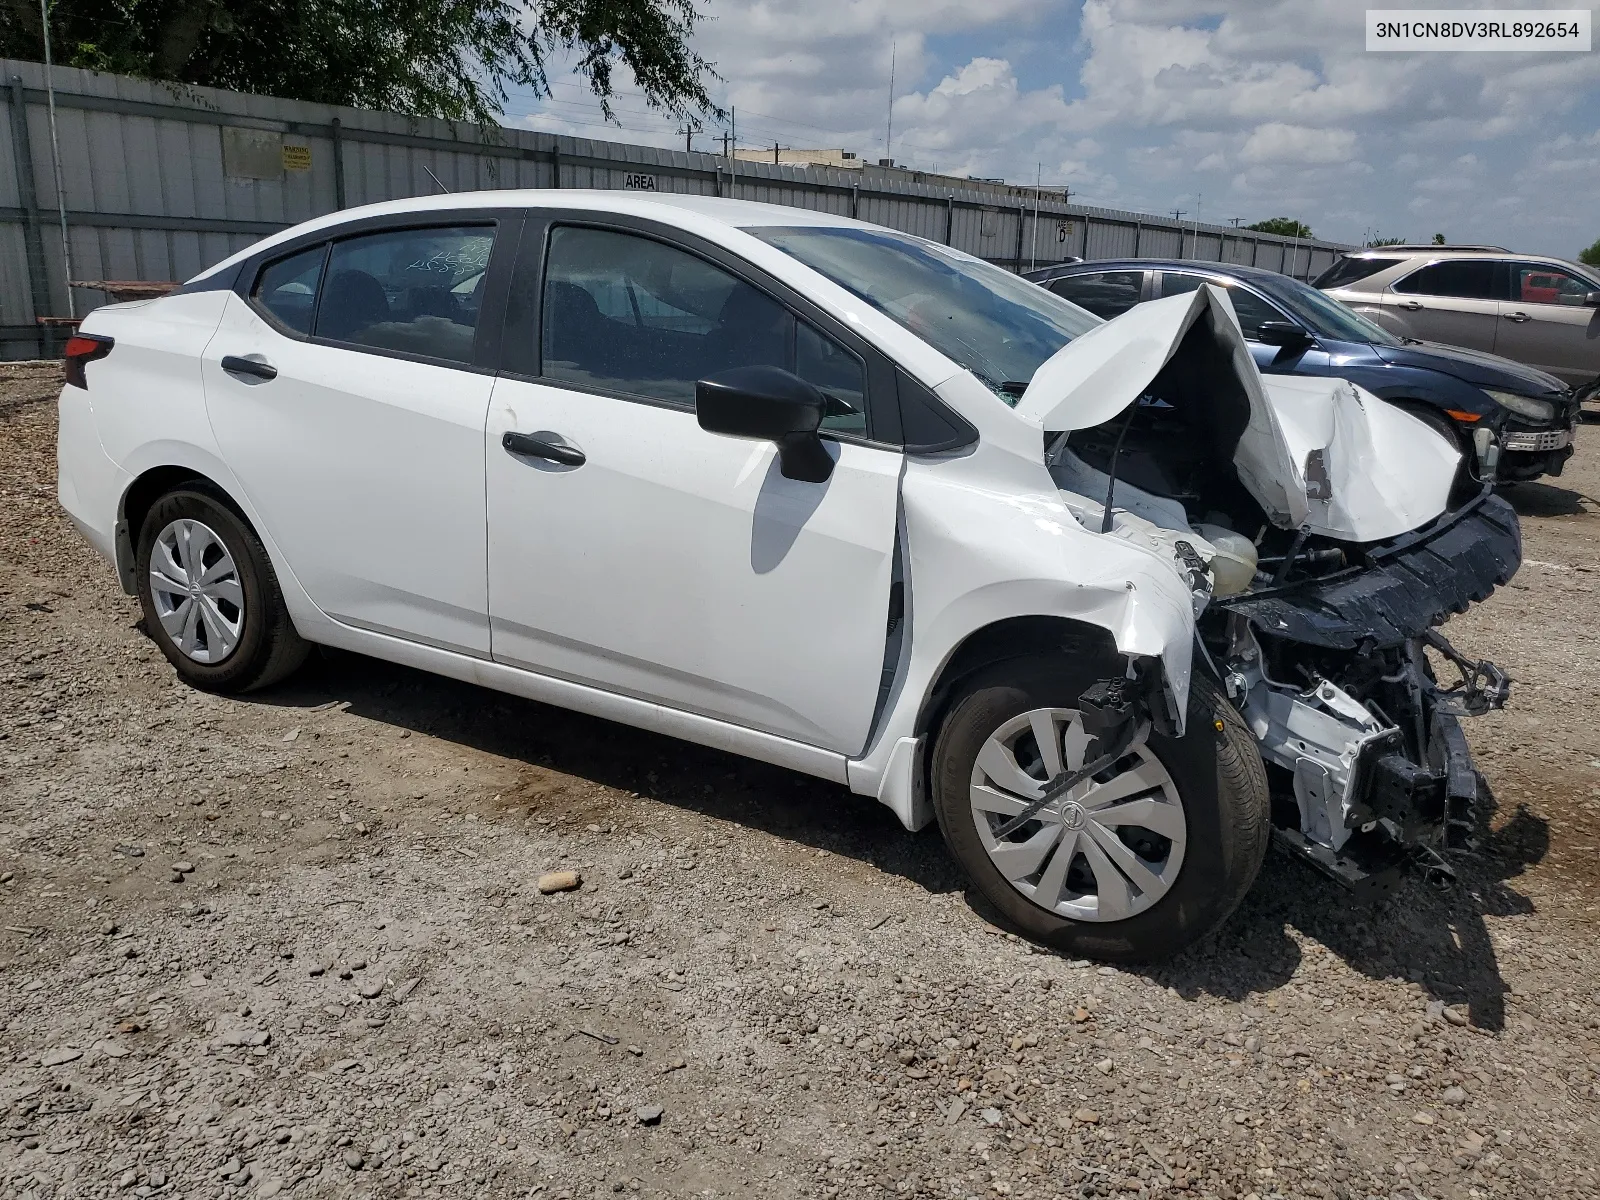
[1315,246,1600,400]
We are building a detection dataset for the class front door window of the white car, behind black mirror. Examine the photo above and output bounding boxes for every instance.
[541,226,867,434]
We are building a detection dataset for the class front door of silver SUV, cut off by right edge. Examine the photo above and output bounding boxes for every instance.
[1494,262,1600,384]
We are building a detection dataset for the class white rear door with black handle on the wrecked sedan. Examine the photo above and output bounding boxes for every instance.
[202,216,520,658]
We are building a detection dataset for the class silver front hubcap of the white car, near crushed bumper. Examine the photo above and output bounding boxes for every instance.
[971,709,1189,922]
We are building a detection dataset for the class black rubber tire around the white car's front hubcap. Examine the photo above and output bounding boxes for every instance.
[931,658,1270,962]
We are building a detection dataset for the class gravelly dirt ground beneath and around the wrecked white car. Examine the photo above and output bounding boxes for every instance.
[0,366,1600,1200]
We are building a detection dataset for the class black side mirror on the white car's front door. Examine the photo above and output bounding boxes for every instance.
[694,366,834,483]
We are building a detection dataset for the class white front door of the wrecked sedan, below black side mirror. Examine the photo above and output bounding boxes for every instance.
[485,214,901,754]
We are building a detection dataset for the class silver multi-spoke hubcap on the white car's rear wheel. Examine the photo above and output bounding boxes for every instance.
[150,520,245,666]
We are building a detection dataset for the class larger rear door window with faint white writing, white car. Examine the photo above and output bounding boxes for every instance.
[315,226,494,363]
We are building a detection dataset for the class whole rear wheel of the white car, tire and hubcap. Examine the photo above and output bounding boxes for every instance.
[134,488,310,691]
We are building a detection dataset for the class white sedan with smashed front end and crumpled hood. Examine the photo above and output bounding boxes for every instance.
[59,200,1520,960]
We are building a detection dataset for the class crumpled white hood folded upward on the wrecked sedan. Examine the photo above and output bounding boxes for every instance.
[1016,285,1459,542]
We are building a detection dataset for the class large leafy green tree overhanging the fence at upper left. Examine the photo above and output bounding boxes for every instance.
[0,0,722,125]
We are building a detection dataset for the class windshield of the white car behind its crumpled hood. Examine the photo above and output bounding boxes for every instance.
[746,226,1101,405]
